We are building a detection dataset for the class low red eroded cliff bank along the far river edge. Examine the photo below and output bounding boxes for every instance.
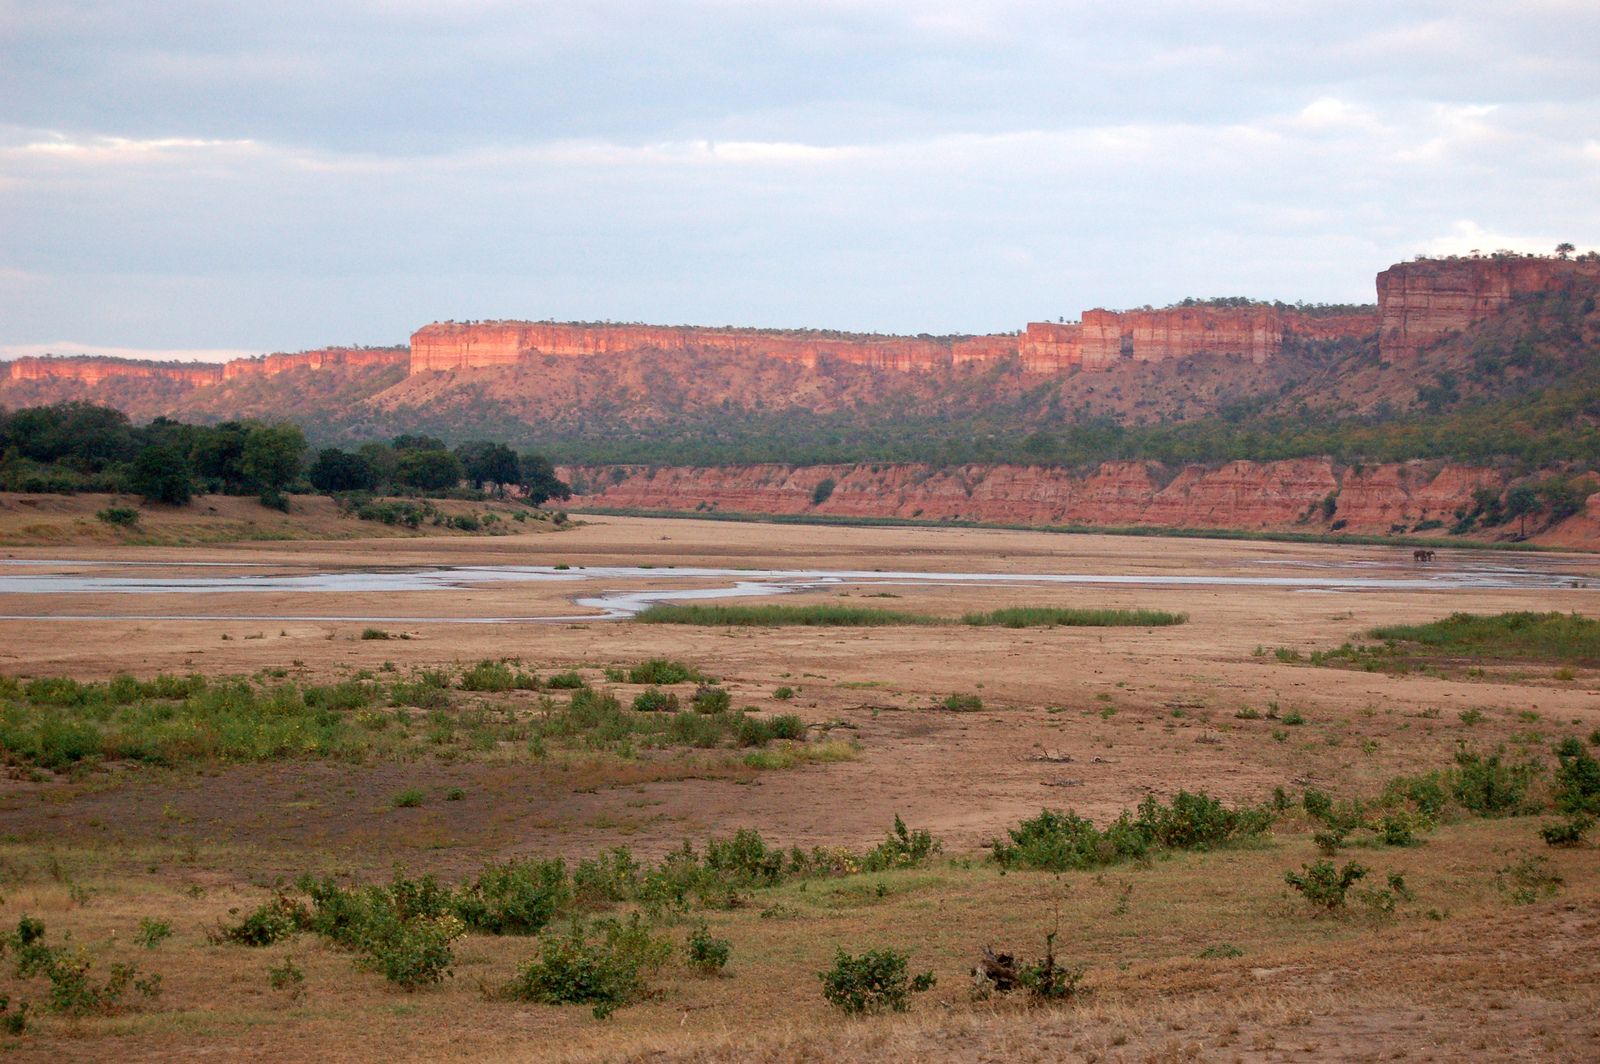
[563,458,1548,533]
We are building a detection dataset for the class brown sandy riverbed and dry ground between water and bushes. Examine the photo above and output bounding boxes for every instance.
[0,517,1600,1061]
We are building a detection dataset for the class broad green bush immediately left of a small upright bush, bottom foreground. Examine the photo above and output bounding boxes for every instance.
[506,914,672,1019]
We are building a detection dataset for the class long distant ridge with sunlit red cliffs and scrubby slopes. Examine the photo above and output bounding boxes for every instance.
[0,256,1600,466]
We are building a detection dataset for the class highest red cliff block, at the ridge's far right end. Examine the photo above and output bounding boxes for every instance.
[1378,258,1600,358]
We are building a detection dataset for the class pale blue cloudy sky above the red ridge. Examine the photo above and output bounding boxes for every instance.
[0,0,1600,358]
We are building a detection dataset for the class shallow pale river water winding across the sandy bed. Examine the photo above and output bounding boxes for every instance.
[0,560,1594,624]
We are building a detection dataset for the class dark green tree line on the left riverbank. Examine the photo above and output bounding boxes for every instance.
[0,402,571,509]
